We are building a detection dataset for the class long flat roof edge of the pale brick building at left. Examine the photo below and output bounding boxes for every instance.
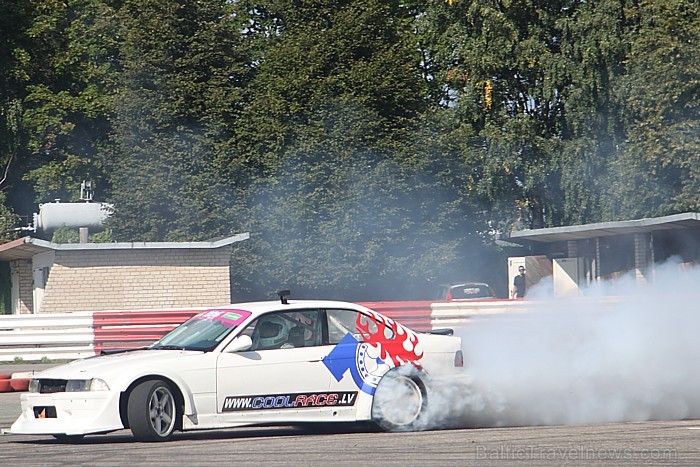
[0,232,250,261]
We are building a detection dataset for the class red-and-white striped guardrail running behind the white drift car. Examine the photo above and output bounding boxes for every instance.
[0,300,527,362]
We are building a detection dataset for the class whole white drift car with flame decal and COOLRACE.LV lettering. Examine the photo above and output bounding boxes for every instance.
[10,294,462,441]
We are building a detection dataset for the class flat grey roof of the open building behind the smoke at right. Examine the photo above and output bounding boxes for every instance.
[508,212,700,245]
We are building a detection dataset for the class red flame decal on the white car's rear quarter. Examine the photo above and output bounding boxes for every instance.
[356,313,423,368]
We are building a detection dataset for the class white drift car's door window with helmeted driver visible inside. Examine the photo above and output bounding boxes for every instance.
[243,310,322,351]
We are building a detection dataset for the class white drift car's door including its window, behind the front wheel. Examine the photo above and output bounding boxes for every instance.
[217,309,337,423]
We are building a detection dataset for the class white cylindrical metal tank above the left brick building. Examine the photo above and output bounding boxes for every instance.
[34,201,113,232]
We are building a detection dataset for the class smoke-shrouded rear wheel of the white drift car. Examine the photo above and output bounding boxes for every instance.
[372,369,428,431]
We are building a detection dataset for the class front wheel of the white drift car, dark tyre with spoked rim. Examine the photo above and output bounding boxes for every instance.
[127,380,178,441]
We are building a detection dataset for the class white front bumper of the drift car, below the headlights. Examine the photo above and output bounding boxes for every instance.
[10,391,124,435]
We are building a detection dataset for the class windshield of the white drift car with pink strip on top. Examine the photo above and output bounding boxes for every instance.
[150,310,250,351]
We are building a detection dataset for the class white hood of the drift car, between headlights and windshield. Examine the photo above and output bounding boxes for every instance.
[35,350,202,379]
